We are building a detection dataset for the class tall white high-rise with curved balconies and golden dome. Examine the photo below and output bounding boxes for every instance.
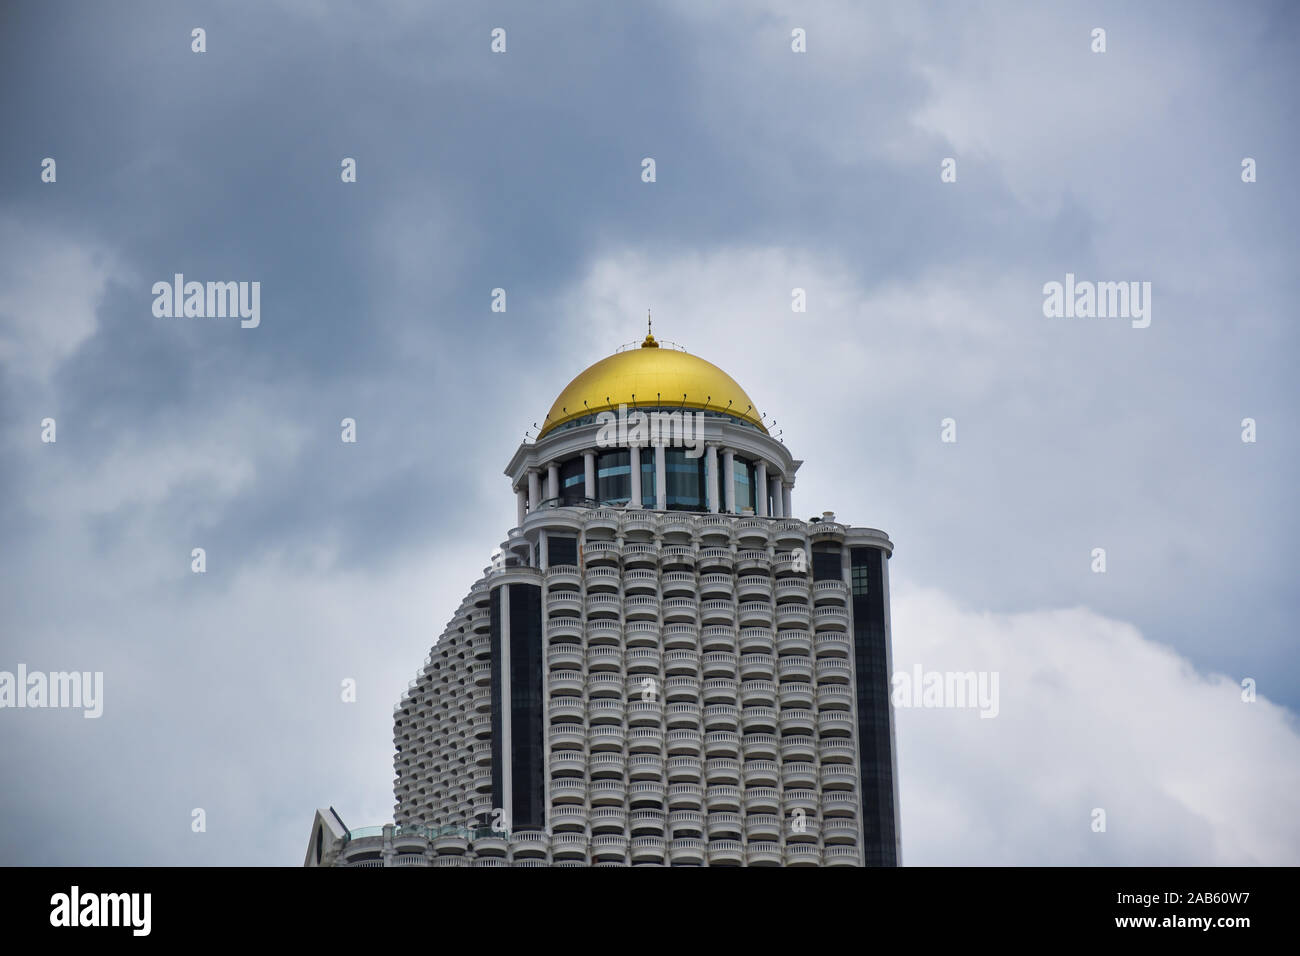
[308,334,900,866]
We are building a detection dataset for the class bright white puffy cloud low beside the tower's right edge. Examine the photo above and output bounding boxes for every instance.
[893,581,1300,866]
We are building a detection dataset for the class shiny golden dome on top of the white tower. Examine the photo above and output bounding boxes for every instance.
[537,334,767,438]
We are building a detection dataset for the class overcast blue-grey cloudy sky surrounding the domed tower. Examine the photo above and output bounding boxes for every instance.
[0,0,1300,865]
